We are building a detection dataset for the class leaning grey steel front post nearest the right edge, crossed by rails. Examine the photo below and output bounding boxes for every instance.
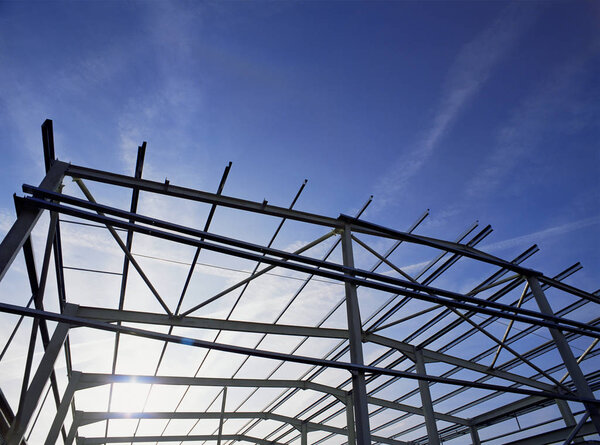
[527,277,600,433]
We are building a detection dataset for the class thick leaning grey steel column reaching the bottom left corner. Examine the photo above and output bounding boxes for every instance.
[6,311,73,445]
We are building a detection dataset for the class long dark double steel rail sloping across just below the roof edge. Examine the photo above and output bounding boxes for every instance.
[16,195,600,337]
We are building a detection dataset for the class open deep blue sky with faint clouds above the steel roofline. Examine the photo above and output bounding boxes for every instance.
[0,1,600,290]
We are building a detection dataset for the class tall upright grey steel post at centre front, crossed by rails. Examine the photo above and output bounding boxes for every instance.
[342,225,371,445]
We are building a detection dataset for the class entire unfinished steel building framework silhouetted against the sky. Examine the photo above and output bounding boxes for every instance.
[0,120,600,445]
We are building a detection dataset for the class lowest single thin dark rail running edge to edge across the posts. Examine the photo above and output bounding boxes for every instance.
[0,303,600,405]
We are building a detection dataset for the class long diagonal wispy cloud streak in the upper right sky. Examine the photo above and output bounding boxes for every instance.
[376,4,533,207]
